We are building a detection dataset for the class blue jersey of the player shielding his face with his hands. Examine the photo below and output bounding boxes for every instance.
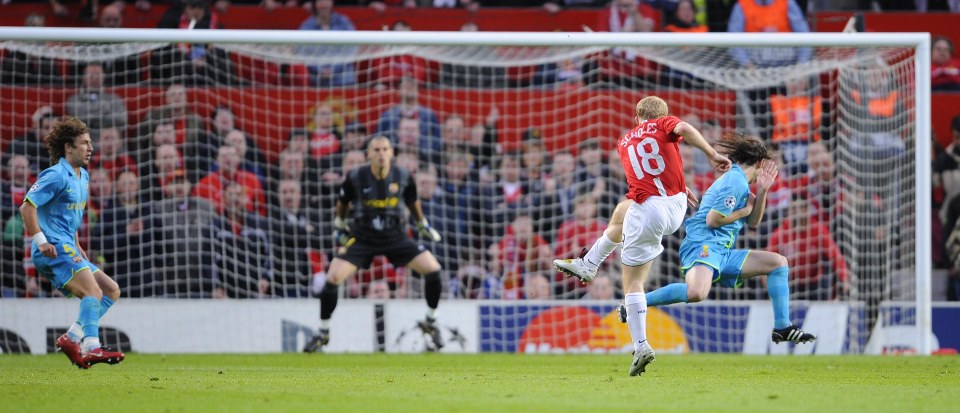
[684,164,750,248]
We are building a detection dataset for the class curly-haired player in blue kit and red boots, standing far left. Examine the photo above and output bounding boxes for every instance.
[20,117,124,369]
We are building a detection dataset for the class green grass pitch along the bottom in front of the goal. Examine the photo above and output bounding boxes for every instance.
[0,354,960,413]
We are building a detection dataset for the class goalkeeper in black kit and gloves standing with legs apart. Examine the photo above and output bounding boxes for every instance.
[303,136,443,353]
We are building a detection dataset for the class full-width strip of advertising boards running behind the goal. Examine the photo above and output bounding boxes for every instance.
[0,299,960,355]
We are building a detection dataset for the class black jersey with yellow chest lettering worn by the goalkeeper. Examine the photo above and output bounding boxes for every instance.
[340,164,417,240]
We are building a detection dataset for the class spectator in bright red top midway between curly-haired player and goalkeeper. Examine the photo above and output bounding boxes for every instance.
[193,145,267,216]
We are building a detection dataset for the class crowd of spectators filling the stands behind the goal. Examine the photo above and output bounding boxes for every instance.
[0,0,960,300]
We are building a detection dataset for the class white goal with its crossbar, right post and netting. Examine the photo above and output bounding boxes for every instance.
[0,30,930,353]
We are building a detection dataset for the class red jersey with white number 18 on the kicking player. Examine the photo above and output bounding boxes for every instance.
[617,116,687,203]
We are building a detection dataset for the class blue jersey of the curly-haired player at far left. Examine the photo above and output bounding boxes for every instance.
[24,158,90,247]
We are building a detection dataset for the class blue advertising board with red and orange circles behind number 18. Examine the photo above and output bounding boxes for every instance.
[480,302,863,354]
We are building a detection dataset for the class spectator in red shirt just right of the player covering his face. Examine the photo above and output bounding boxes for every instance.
[767,196,850,300]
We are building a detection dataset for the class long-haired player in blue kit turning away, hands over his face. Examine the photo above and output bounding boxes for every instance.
[647,132,816,343]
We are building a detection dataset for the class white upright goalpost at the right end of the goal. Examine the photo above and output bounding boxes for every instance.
[914,34,933,355]
